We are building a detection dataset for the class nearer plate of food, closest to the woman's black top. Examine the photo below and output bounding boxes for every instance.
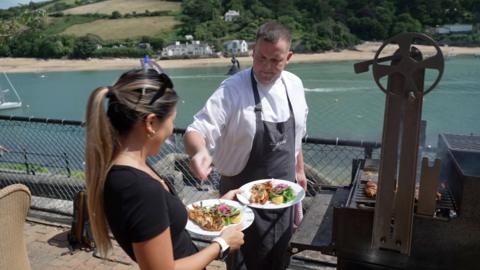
[186,199,255,236]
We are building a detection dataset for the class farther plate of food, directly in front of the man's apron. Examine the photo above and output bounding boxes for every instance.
[237,179,305,209]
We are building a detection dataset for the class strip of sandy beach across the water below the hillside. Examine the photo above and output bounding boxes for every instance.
[0,42,480,73]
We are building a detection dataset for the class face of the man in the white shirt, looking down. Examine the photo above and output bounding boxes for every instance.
[253,39,292,84]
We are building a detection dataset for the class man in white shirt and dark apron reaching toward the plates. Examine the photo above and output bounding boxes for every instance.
[184,22,308,270]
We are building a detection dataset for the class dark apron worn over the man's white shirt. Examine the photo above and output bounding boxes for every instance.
[220,69,295,270]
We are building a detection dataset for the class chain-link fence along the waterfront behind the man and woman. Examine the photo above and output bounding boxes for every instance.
[0,116,380,214]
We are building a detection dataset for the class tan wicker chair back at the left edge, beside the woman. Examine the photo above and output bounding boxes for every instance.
[0,184,31,270]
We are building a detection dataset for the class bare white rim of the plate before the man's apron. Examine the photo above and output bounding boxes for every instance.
[237,179,305,209]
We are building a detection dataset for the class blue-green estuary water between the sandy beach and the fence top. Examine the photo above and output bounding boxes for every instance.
[0,57,480,145]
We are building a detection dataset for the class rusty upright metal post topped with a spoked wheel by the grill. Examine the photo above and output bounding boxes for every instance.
[355,33,443,255]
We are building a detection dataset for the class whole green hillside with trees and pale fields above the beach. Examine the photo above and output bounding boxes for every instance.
[0,0,480,58]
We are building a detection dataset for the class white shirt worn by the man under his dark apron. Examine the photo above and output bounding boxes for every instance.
[187,68,308,176]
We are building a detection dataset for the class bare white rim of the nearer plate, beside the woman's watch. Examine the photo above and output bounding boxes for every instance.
[185,199,255,236]
